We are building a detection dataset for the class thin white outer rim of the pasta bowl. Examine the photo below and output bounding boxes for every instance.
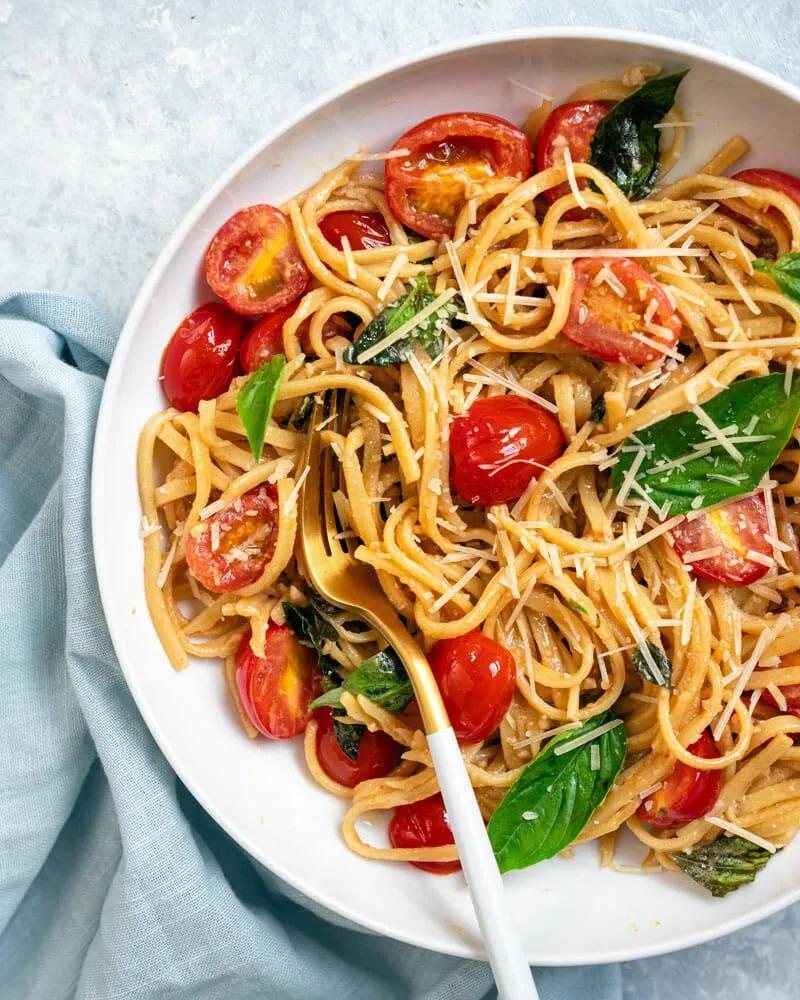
[90,26,800,966]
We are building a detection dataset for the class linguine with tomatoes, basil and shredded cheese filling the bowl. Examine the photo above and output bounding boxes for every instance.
[138,65,800,896]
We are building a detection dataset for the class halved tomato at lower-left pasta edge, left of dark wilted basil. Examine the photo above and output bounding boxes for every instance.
[236,622,320,740]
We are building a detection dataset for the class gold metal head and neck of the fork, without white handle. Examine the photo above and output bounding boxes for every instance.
[298,392,450,733]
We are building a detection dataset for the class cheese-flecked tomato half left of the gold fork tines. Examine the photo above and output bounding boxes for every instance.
[186,483,278,594]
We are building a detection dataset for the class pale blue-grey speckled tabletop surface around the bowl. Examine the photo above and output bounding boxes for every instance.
[0,0,800,1000]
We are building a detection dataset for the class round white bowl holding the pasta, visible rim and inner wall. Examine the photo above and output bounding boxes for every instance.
[92,29,800,965]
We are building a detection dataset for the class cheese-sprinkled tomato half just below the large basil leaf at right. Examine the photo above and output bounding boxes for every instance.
[672,493,772,587]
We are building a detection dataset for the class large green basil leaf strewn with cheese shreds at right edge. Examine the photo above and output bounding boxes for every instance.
[611,374,800,515]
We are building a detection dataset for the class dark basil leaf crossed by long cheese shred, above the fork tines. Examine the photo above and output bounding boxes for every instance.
[344,274,464,367]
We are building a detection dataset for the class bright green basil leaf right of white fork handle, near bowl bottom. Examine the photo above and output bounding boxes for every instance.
[488,712,627,872]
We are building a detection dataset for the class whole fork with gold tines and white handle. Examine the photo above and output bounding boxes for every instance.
[298,391,538,1000]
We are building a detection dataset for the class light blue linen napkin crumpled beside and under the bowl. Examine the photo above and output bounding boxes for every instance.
[0,293,621,1000]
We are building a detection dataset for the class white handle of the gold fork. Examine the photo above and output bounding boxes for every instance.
[428,726,539,1000]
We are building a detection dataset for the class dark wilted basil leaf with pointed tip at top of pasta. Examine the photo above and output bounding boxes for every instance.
[589,69,689,201]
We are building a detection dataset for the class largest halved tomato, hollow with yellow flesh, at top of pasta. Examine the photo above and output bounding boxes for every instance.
[385,111,533,240]
